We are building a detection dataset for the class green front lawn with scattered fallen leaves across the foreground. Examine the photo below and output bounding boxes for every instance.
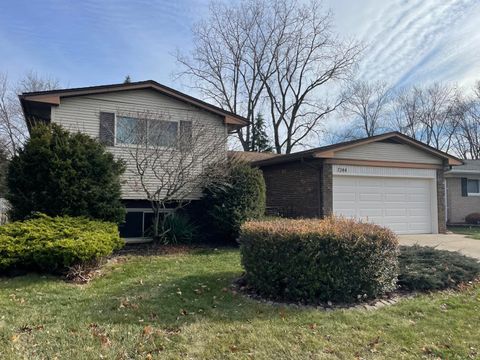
[0,250,480,359]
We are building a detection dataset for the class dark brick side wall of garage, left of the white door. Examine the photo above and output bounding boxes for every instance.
[262,160,321,217]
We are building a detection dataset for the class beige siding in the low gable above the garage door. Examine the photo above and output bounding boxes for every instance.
[335,142,442,164]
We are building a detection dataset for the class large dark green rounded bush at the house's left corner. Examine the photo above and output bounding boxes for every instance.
[6,124,125,224]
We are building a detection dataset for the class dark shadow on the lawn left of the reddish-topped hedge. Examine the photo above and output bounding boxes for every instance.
[78,272,277,327]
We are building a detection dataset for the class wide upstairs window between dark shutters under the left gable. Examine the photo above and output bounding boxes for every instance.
[116,116,178,147]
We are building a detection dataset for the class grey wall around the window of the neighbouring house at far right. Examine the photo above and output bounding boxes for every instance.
[446,176,480,223]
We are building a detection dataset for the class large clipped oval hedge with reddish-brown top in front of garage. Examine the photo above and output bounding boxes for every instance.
[240,217,398,303]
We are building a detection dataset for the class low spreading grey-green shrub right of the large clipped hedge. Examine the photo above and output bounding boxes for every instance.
[398,246,480,291]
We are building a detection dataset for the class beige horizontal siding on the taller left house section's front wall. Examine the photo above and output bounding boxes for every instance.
[51,90,227,199]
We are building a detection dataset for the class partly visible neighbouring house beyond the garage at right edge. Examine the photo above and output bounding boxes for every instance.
[445,160,480,224]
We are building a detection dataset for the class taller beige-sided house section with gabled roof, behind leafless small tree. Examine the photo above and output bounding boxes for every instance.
[20,80,247,237]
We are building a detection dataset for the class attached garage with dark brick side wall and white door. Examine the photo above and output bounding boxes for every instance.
[252,132,462,234]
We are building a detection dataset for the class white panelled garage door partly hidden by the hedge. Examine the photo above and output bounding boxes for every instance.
[333,176,434,234]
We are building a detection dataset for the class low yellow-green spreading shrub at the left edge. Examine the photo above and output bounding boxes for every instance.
[0,215,124,272]
